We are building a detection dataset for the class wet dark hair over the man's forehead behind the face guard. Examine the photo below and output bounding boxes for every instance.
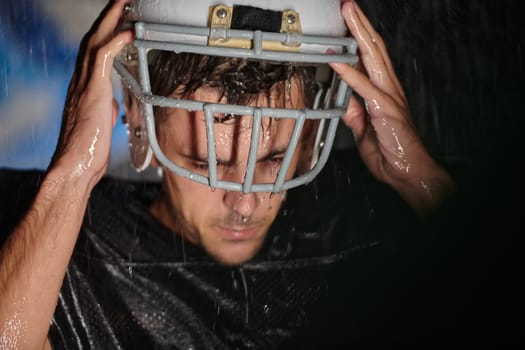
[150,51,316,107]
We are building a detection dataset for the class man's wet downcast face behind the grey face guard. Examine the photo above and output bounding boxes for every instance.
[152,83,308,265]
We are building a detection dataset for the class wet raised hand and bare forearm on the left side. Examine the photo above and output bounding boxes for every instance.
[0,0,133,349]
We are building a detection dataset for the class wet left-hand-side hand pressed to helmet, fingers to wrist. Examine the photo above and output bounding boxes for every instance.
[49,0,133,192]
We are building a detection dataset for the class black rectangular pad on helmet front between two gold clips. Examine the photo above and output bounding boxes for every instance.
[231,5,283,33]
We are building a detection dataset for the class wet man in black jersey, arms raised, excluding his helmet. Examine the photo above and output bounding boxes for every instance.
[0,1,453,349]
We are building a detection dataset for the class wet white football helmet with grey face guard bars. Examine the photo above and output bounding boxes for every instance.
[114,0,357,193]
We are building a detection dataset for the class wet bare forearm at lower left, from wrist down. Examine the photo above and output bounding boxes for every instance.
[0,167,89,349]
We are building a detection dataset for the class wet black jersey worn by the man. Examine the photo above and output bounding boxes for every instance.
[0,150,418,349]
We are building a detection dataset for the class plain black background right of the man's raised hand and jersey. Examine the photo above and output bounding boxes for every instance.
[361,0,525,344]
